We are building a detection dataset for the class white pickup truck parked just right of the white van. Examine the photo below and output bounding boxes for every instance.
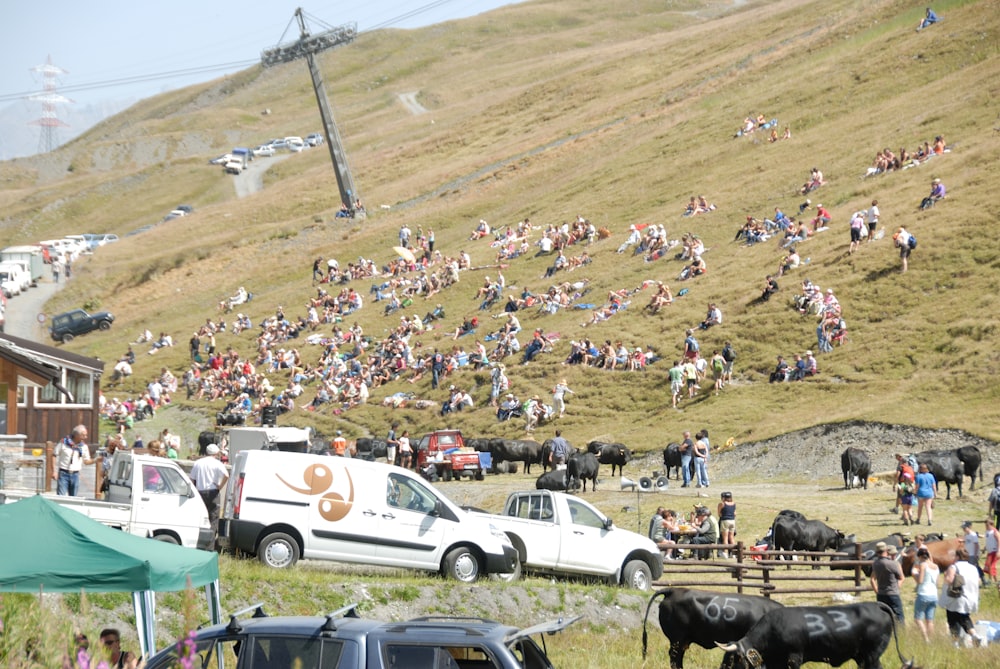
[470,490,663,590]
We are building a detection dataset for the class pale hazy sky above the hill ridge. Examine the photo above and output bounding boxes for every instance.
[0,0,521,106]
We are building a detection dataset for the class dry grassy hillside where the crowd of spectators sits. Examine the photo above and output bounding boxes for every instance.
[0,0,1000,448]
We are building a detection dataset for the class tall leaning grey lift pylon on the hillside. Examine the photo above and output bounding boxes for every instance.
[260,7,359,215]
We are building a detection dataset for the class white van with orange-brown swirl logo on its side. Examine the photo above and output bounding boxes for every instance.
[219,450,517,583]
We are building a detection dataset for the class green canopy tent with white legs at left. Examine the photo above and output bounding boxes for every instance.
[0,495,221,657]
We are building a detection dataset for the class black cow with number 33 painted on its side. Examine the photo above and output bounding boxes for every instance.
[718,602,913,669]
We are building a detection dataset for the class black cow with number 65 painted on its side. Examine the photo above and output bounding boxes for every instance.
[642,588,781,669]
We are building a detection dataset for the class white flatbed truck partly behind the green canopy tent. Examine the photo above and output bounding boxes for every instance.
[0,451,214,549]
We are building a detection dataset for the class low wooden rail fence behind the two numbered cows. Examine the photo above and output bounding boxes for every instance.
[654,542,872,597]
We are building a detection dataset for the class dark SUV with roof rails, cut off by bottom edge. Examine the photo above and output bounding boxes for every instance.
[146,604,579,669]
